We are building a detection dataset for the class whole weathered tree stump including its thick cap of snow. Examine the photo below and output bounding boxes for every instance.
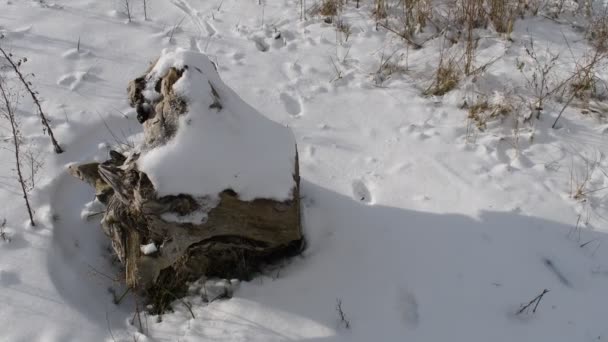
[69,49,302,310]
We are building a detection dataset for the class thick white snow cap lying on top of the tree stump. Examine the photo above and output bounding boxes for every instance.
[138,48,295,201]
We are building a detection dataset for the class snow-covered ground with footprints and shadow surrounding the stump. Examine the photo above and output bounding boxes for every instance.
[0,0,608,342]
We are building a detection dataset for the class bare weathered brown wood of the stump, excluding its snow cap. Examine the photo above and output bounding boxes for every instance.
[69,52,302,311]
